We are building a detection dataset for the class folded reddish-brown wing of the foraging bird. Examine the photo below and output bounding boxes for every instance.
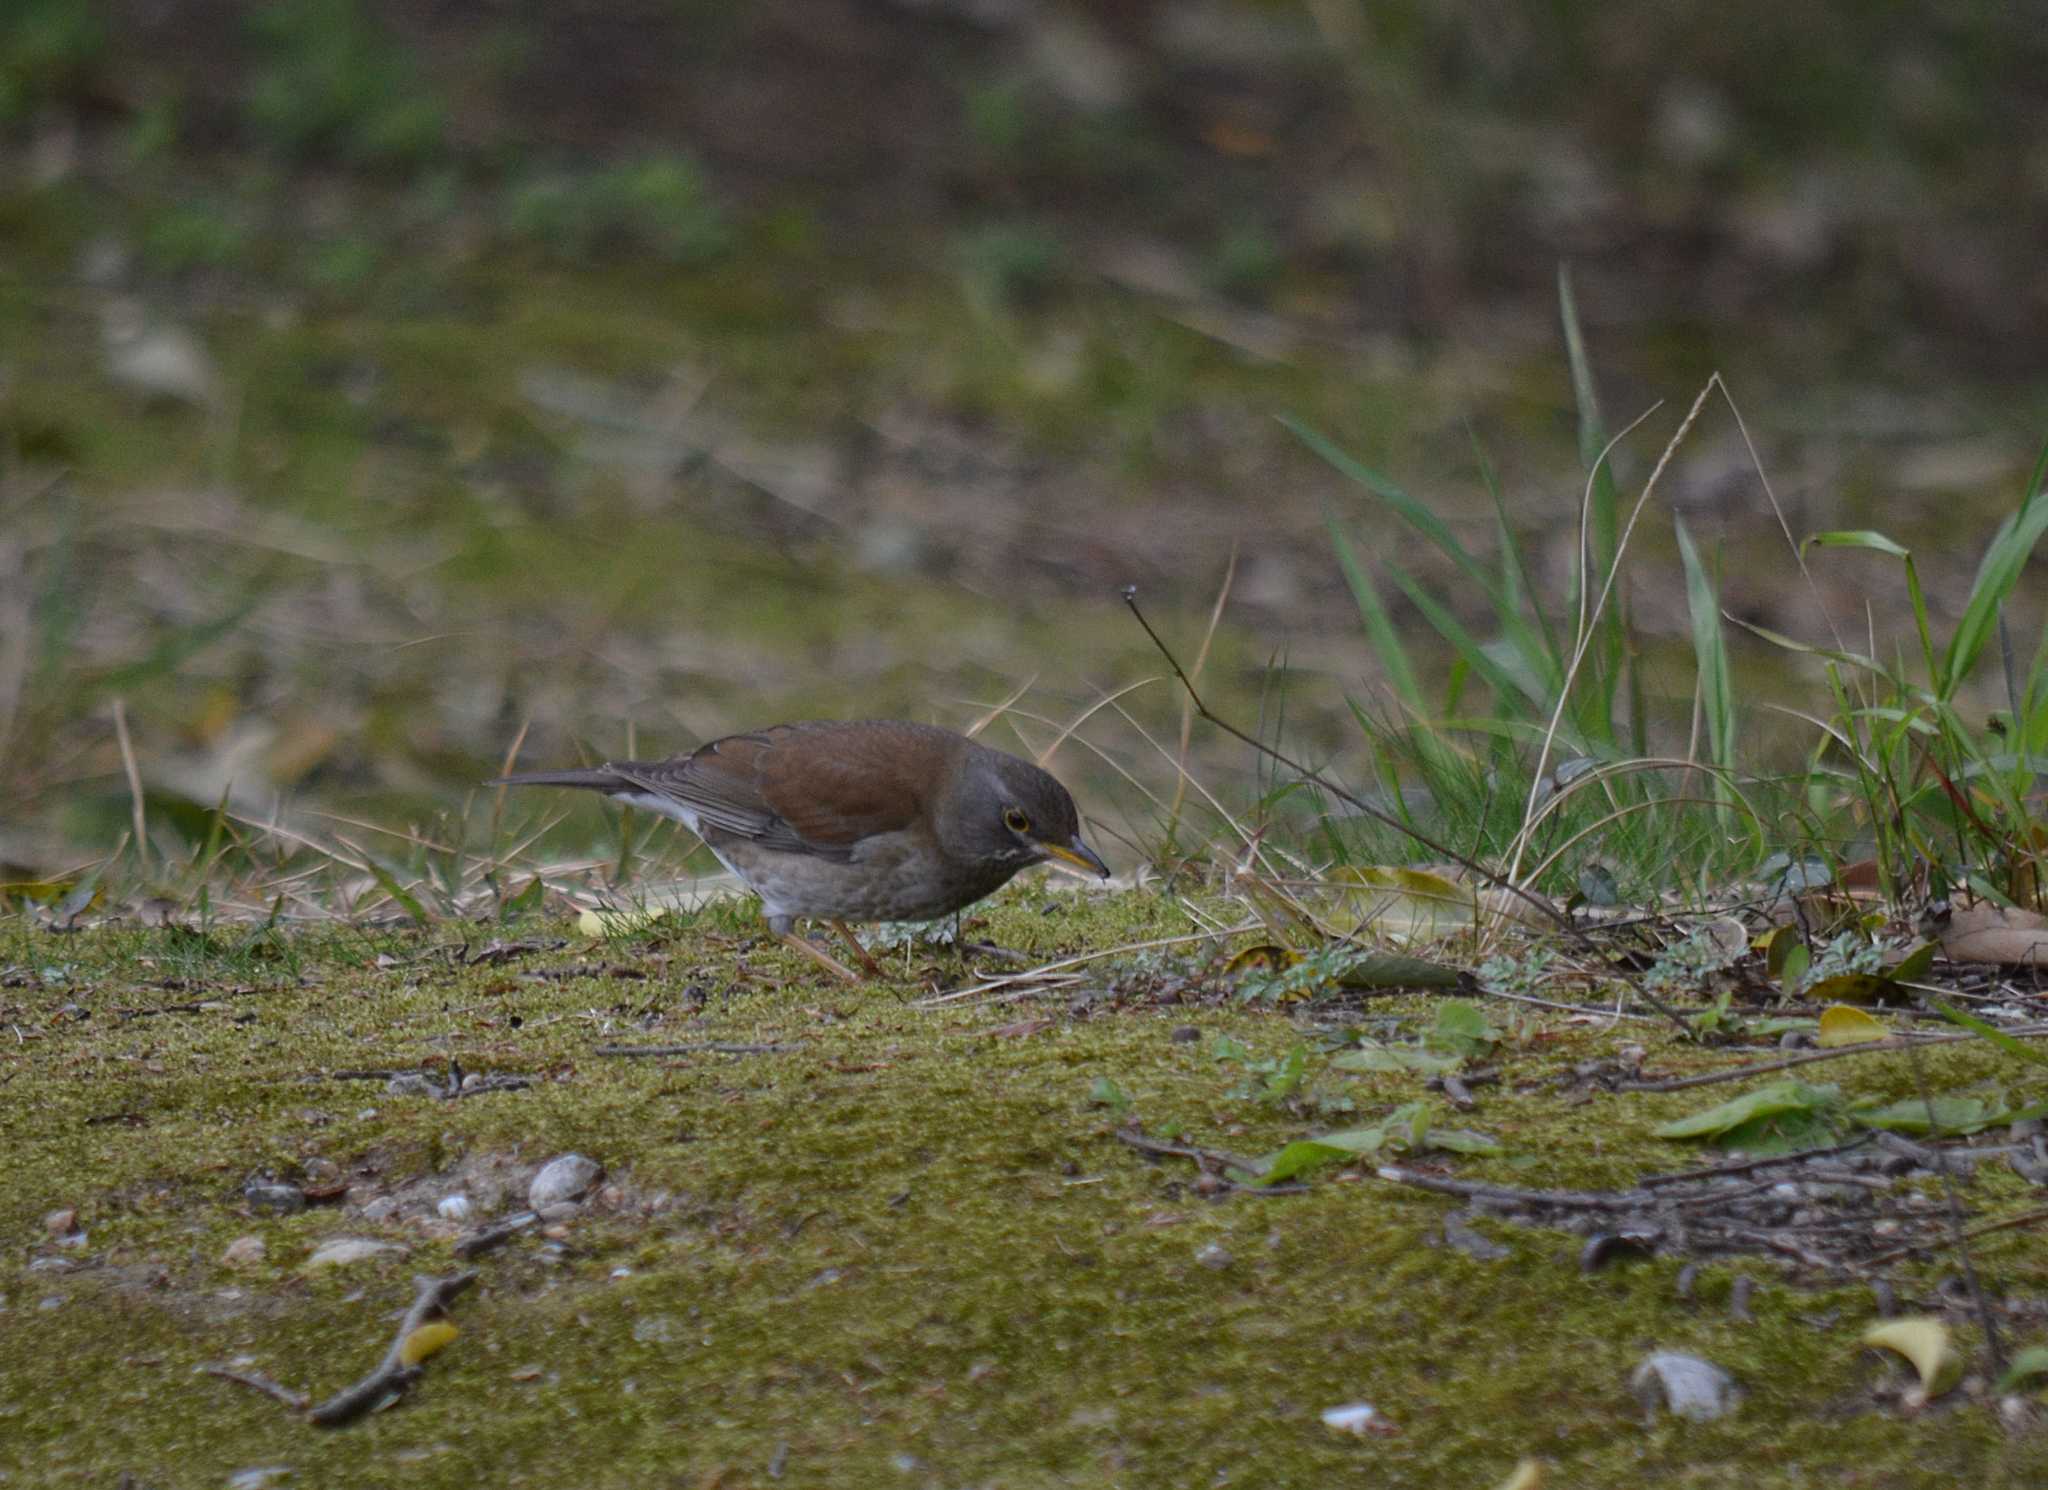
[608,722,950,860]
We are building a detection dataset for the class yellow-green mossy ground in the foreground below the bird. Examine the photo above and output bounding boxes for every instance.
[0,884,2048,1490]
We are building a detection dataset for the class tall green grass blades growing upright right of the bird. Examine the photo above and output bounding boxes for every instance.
[1288,276,2048,911]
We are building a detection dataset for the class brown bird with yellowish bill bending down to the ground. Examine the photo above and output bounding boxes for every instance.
[489,718,1110,982]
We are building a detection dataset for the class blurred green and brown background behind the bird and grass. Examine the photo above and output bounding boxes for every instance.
[0,0,2048,878]
